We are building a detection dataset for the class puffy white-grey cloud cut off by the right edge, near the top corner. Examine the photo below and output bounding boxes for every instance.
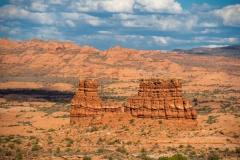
[213,4,240,27]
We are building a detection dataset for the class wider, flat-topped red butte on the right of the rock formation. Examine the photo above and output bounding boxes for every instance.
[125,78,197,119]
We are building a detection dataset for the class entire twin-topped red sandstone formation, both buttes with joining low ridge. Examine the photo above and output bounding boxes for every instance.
[71,78,197,121]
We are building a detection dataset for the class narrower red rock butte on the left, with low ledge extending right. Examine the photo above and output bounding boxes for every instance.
[70,79,121,121]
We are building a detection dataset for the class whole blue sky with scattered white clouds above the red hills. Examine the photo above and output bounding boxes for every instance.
[0,0,240,50]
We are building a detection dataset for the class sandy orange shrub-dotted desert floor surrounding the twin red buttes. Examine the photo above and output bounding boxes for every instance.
[0,73,240,160]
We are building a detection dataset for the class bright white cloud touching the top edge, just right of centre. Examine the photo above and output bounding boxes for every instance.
[134,0,183,13]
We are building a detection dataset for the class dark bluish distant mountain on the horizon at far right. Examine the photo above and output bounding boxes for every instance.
[172,44,240,58]
